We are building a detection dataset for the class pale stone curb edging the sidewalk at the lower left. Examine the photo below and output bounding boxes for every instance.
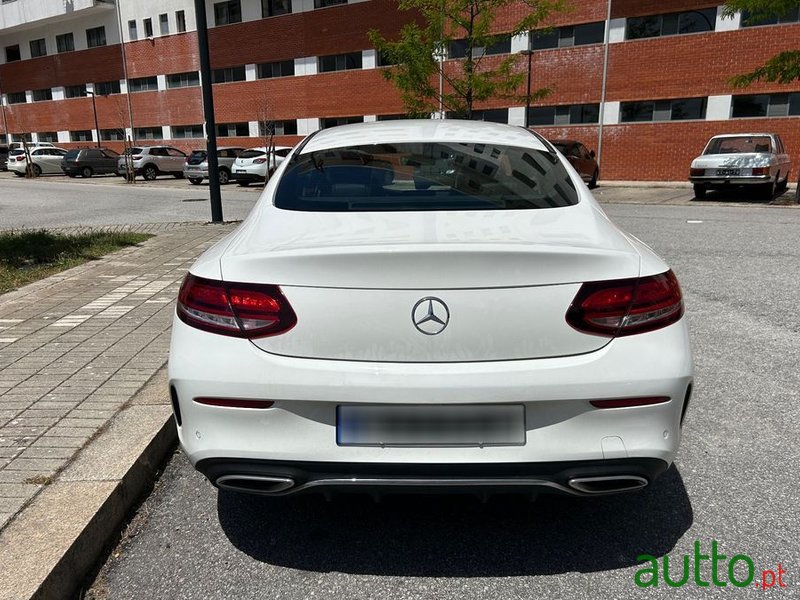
[0,367,177,600]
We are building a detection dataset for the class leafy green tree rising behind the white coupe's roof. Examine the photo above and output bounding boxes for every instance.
[369,0,566,119]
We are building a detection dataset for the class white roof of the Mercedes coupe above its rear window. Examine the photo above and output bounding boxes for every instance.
[303,119,548,153]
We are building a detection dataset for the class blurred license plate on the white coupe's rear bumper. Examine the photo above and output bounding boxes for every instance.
[336,404,525,446]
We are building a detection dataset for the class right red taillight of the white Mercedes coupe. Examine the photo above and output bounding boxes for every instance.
[566,271,683,337]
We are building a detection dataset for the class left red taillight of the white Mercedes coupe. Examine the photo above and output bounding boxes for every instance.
[177,275,297,338]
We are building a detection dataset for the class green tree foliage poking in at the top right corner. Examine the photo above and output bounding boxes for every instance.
[723,0,800,87]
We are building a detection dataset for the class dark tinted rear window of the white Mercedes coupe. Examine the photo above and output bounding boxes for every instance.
[275,142,578,212]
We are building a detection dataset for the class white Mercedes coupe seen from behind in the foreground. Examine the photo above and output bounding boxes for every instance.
[169,120,693,496]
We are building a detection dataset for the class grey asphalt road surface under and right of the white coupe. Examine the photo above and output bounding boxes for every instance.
[79,204,800,600]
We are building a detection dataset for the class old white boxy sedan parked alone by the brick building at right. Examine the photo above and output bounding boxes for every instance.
[689,133,791,199]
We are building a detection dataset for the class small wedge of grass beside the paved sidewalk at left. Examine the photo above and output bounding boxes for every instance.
[0,229,153,294]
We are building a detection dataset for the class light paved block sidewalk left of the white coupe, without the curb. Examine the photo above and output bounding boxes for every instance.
[0,224,234,528]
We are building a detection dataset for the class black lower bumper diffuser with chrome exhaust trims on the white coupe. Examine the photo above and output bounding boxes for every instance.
[196,458,669,496]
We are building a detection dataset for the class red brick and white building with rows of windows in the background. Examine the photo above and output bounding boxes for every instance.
[0,0,800,180]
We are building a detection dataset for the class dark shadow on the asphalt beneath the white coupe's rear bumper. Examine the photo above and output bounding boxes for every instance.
[217,466,693,577]
